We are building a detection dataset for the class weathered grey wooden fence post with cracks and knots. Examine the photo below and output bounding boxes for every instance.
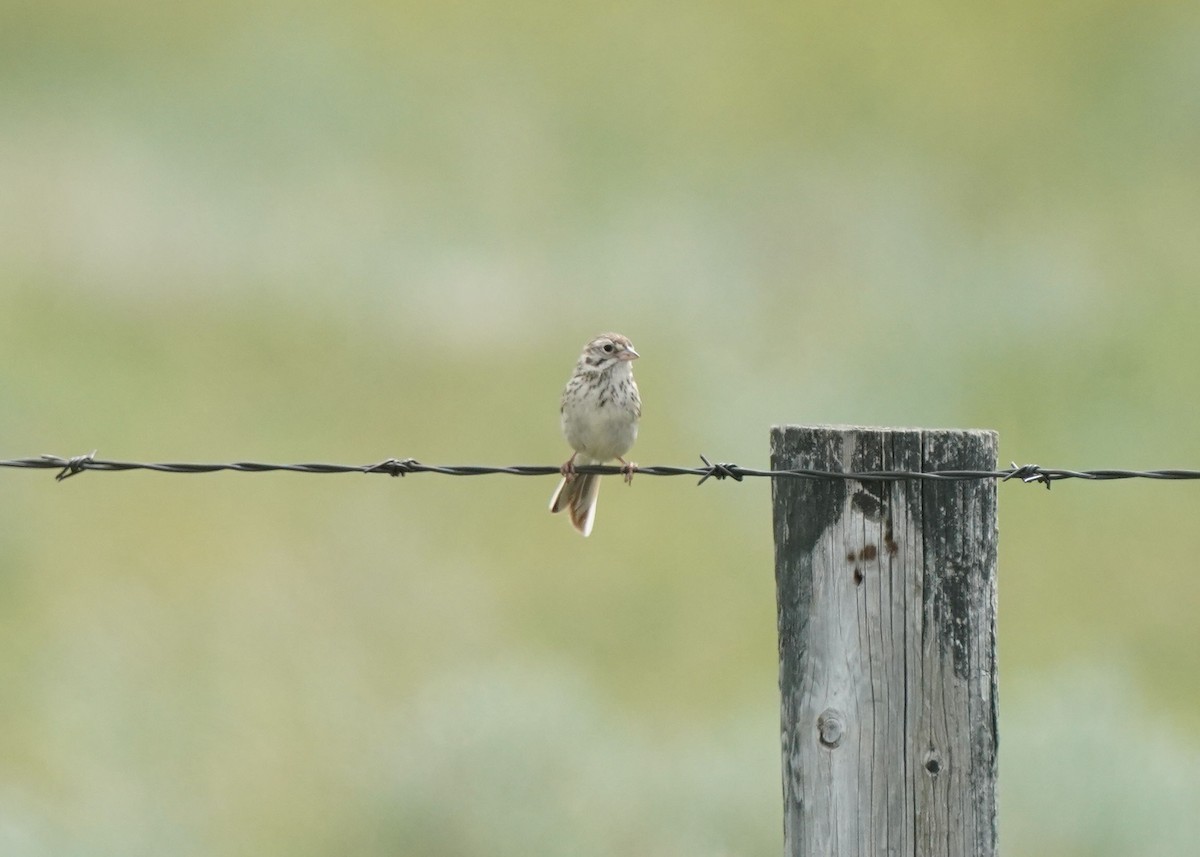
[770,426,997,857]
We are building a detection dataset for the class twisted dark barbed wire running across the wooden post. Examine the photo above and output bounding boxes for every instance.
[7,450,1200,489]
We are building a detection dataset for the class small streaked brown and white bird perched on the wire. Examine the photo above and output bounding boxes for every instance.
[550,334,642,535]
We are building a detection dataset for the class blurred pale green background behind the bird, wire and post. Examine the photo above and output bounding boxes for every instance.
[0,0,1200,857]
